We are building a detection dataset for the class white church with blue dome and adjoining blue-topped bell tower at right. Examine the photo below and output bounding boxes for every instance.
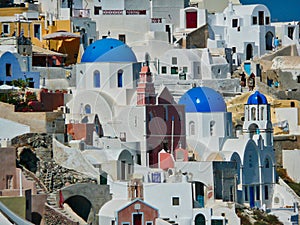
[177,87,276,208]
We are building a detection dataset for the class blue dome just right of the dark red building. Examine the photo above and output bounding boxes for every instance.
[178,87,227,112]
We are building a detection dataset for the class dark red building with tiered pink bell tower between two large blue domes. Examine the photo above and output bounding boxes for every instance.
[137,66,186,167]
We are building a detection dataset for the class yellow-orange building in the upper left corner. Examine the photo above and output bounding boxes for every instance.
[0,6,80,65]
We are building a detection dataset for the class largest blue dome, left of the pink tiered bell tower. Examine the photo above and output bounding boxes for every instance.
[81,38,137,62]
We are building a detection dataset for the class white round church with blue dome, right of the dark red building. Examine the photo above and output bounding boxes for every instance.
[178,87,232,155]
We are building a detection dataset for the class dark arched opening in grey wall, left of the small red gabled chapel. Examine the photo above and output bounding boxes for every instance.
[64,195,92,221]
